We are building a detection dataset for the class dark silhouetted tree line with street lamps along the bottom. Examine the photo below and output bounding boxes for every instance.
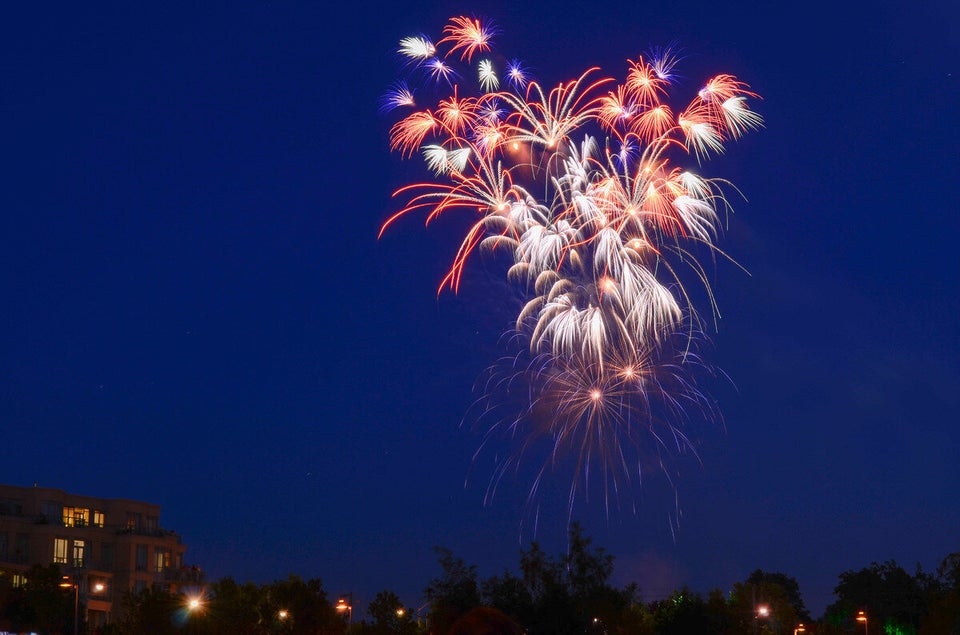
[0,524,960,635]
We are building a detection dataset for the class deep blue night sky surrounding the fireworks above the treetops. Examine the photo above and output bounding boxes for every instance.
[0,0,960,617]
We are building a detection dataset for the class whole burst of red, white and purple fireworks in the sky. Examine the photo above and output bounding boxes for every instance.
[380,16,762,514]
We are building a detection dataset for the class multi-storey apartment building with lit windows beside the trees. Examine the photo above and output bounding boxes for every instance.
[0,485,203,626]
